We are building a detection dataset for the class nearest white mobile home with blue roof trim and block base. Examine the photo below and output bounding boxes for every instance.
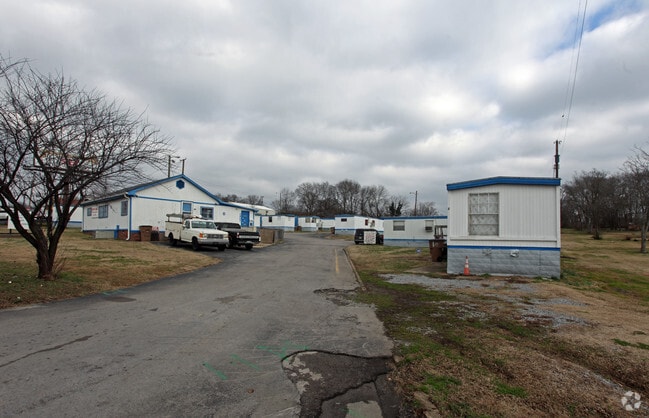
[446,177,561,277]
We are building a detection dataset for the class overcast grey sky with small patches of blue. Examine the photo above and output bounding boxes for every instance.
[0,0,649,212]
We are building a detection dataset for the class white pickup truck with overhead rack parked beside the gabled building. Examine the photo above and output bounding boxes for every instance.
[165,214,229,251]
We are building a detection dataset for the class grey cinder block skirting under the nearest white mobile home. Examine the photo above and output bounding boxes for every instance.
[446,246,561,278]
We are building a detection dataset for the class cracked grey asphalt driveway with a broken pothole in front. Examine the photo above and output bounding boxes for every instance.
[0,233,398,417]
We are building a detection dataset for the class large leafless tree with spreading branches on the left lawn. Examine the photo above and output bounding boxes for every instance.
[0,57,171,280]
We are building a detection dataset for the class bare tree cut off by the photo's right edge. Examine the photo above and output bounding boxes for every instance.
[623,147,649,254]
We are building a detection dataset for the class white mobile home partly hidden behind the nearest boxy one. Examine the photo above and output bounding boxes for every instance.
[383,216,447,247]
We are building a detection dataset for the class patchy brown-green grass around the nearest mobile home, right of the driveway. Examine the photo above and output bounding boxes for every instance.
[349,231,649,417]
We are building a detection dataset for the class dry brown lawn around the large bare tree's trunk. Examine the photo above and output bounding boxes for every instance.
[0,230,218,308]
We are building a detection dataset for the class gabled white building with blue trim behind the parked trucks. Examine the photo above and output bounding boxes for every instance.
[82,175,254,239]
